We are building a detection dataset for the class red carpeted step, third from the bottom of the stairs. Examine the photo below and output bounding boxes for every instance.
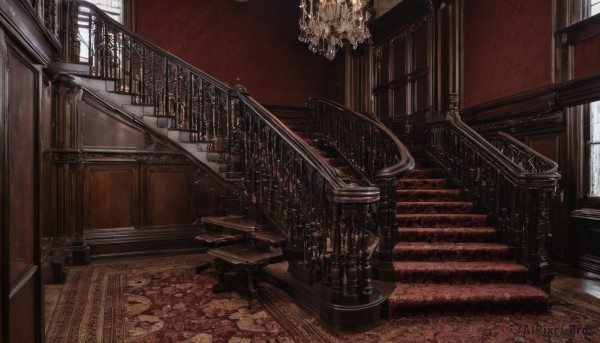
[392,242,508,261]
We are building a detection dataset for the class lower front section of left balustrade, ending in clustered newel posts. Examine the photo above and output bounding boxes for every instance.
[236,96,379,303]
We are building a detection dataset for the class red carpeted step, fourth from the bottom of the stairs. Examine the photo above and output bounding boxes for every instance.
[398,227,496,242]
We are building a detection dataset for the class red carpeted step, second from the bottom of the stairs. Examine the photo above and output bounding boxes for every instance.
[394,261,527,284]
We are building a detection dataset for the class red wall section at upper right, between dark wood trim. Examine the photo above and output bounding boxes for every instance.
[462,0,552,108]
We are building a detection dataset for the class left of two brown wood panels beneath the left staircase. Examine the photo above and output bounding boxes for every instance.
[83,163,139,230]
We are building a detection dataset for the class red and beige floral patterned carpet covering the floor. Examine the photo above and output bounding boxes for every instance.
[46,255,600,343]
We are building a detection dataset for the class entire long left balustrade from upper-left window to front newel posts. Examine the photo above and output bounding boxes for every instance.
[63,1,390,310]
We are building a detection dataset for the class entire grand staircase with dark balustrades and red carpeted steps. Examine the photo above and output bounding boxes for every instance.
[56,2,556,329]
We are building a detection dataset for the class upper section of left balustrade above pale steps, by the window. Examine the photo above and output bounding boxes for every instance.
[63,1,233,152]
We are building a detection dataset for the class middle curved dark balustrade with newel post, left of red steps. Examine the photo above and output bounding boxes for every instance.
[307,98,415,281]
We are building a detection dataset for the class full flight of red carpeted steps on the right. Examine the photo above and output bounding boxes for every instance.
[389,165,548,316]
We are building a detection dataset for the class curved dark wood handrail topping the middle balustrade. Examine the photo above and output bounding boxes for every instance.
[308,97,415,182]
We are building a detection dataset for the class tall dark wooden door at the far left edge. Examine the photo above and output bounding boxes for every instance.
[0,41,42,342]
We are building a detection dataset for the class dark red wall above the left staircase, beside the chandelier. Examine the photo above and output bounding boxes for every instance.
[136,0,335,105]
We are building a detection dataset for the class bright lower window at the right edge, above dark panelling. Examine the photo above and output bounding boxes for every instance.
[588,101,600,197]
